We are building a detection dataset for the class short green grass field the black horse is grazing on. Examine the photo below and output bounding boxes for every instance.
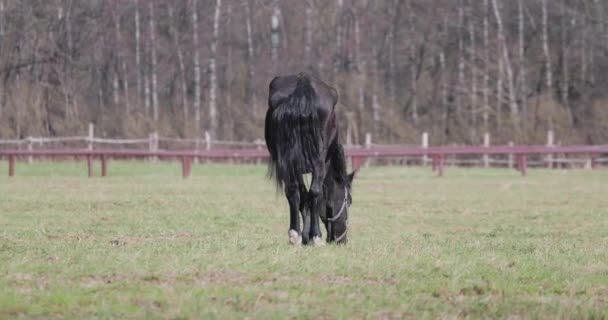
[0,162,608,319]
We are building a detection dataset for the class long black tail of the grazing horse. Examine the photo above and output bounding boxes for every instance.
[270,75,323,187]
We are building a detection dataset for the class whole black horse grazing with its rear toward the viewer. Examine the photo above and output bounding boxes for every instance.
[264,73,352,245]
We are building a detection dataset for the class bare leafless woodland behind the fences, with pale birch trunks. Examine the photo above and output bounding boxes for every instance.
[0,0,608,145]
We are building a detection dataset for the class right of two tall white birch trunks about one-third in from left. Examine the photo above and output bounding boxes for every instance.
[209,0,222,139]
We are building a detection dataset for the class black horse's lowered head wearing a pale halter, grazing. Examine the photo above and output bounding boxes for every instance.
[323,171,356,243]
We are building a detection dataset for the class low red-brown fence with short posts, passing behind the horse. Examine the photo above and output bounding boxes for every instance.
[0,145,608,178]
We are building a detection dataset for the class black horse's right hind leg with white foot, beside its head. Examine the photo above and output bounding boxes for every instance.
[309,161,327,245]
